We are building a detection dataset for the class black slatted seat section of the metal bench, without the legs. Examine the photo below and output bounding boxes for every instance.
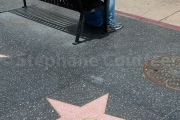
[40,0,83,12]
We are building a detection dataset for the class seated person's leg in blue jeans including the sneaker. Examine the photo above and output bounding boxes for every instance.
[107,0,123,32]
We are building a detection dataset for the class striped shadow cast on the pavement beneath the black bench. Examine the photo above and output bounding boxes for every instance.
[9,6,108,43]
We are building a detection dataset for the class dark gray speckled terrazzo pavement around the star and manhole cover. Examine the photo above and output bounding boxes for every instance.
[0,0,180,120]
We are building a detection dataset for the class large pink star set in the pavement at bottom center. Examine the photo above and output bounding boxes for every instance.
[47,94,123,120]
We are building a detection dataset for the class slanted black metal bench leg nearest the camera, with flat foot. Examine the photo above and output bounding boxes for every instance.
[73,13,84,45]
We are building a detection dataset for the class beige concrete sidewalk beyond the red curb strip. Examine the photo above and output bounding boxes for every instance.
[116,0,180,27]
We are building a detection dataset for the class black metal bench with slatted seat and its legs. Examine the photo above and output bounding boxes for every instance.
[23,0,107,45]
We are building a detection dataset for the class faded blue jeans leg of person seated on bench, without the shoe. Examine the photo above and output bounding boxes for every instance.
[107,0,116,24]
